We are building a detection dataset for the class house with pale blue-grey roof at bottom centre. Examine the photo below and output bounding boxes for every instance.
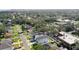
[33,35,48,44]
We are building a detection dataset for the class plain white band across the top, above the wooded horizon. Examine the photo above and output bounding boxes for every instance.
[0,0,79,10]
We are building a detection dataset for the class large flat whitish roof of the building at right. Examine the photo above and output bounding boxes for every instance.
[59,32,79,44]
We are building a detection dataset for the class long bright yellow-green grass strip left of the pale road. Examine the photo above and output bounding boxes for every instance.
[12,25,22,48]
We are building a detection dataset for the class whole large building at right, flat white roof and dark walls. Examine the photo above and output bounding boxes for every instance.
[59,32,79,49]
